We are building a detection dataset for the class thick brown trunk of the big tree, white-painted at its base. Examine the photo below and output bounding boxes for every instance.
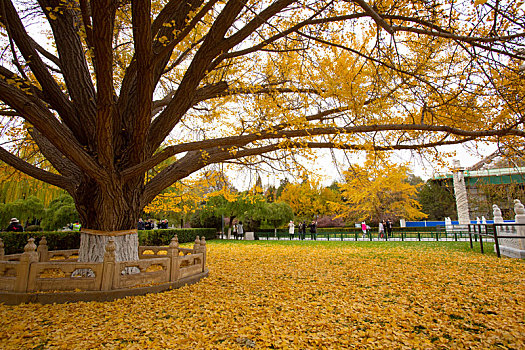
[74,178,143,262]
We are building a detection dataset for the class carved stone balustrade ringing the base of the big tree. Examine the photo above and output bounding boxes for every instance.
[0,236,208,304]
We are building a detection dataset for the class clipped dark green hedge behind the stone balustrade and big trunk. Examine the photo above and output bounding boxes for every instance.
[0,228,217,254]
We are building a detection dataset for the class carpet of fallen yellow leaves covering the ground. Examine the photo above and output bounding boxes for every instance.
[0,242,525,349]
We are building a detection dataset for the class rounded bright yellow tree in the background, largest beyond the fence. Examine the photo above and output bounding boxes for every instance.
[332,160,427,223]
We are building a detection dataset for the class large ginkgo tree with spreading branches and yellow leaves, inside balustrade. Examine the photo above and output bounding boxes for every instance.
[0,0,525,261]
